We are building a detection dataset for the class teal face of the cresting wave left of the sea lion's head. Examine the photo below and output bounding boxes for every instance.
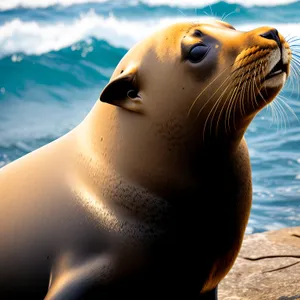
[0,39,127,98]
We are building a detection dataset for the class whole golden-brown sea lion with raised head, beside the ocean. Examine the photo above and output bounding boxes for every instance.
[0,21,291,300]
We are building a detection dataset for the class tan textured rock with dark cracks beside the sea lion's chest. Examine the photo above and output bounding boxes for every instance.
[218,227,300,300]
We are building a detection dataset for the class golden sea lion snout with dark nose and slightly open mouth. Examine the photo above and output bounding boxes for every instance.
[233,26,291,114]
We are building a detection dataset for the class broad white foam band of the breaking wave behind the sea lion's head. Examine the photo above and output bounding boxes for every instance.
[0,10,300,57]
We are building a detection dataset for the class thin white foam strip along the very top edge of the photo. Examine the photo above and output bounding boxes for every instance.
[0,0,297,10]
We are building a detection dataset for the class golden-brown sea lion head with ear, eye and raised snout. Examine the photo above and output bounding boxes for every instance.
[100,21,291,149]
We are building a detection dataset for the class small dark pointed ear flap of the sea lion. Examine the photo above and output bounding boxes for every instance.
[100,68,142,112]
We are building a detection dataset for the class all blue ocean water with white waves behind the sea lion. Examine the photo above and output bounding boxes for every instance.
[0,0,300,233]
